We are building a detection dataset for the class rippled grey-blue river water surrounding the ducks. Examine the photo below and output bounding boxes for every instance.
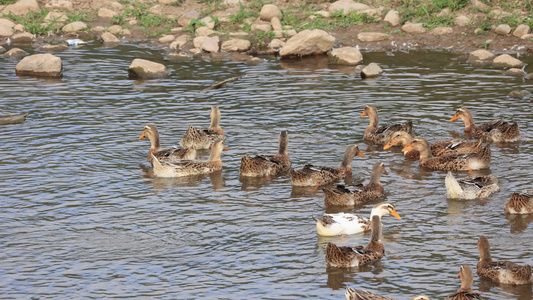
[0,45,533,299]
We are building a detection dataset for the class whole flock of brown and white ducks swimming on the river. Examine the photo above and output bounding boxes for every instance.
[139,105,533,300]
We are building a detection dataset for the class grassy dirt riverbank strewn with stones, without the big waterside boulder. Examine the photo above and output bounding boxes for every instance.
[0,0,533,54]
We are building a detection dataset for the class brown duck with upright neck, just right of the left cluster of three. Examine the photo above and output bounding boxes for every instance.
[239,130,291,177]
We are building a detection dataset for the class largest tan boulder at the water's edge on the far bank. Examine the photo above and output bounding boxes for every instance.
[280,29,335,57]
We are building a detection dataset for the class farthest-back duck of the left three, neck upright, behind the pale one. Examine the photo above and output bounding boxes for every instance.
[180,106,226,149]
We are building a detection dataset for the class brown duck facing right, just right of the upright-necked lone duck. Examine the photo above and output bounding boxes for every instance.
[291,145,365,186]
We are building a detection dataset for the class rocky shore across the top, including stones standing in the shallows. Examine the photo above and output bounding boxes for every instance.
[0,0,533,88]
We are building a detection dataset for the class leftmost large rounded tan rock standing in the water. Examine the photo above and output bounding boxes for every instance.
[15,53,63,78]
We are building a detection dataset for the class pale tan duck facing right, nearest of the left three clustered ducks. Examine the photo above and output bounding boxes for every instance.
[151,141,227,177]
